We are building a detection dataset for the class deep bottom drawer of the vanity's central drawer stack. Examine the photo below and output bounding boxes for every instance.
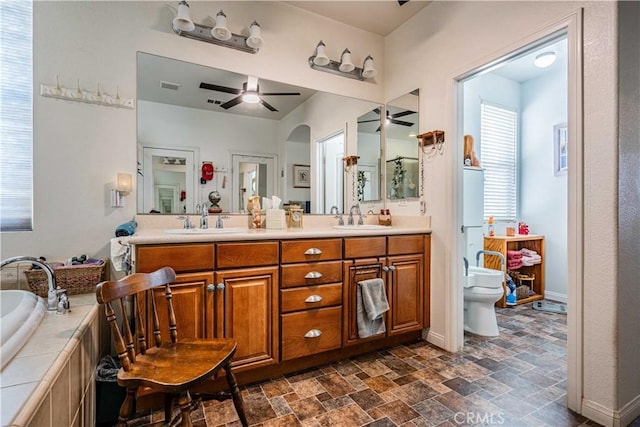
[281,307,342,361]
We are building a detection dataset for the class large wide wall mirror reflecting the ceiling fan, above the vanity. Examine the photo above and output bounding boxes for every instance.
[137,52,382,214]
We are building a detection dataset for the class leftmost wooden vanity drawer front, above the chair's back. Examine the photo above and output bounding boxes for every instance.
[135,244,214,273]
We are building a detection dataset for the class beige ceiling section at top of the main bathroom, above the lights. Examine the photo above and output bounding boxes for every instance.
[284,0,431,36]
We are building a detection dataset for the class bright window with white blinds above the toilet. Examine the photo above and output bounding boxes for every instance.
[480,102,518,222]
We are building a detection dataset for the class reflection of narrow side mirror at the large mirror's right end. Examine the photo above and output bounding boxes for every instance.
[356,106,382,202]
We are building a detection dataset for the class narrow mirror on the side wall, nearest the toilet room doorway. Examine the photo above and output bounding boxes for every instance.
[385,89,420,199]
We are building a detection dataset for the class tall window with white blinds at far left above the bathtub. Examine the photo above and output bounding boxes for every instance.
[0,1,33,231]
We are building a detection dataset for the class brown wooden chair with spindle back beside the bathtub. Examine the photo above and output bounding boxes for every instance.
[96,267,247,426]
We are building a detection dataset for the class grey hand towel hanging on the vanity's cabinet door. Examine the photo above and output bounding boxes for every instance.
[356,278,389,338]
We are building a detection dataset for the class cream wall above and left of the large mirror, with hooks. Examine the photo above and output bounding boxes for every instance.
[2,1,385,259]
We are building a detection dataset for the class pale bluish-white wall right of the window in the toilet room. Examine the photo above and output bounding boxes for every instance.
[519,66,567,301]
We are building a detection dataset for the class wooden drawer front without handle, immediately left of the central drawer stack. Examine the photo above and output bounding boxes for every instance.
[216,242,278,268]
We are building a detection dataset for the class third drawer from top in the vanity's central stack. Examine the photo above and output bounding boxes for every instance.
[280,283,342,313]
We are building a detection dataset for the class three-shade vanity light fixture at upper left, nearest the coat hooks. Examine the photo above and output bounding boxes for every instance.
[172,0,264,53]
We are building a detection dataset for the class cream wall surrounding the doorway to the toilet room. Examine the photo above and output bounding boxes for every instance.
[385,1,624,420]
